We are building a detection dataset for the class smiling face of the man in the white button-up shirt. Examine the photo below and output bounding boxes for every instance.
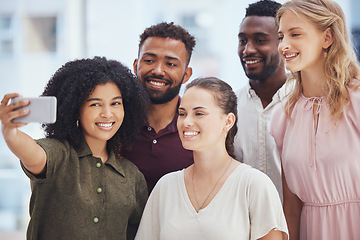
[238,16,281,80]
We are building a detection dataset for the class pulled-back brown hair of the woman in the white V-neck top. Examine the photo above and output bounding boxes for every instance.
[185,77,238,158]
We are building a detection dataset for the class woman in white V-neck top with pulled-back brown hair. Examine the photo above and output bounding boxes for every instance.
[136,78,288,240]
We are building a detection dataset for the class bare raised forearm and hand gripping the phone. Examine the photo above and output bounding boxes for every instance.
[0,93,46,175]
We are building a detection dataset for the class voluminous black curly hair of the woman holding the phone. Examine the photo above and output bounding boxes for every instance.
[42,57,149,156]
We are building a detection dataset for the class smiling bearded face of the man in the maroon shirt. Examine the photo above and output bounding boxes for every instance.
[134,37,192,104]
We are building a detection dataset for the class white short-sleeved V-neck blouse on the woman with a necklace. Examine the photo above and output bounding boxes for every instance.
[135,164,288,240]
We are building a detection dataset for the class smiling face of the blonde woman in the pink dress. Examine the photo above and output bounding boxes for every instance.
[279,11,327,72]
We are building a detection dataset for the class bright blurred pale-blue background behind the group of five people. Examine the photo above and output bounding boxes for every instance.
[0,0,360,236]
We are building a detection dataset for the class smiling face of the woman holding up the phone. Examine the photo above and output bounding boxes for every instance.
[80,82,124,146]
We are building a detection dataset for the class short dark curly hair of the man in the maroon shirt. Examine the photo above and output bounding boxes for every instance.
[139,22,196,64]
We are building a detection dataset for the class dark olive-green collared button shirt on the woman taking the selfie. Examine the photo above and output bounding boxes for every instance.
[22,138,148,240]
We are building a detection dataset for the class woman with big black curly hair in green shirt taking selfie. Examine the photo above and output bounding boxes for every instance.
[0,57,148,239]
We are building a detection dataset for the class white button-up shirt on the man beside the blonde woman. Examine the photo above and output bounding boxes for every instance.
[234,83,285,199]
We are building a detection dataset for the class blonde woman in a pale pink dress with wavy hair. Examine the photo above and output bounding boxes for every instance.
[271,0,360,240]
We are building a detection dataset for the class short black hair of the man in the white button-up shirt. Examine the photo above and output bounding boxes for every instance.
[245,0,281,17]
